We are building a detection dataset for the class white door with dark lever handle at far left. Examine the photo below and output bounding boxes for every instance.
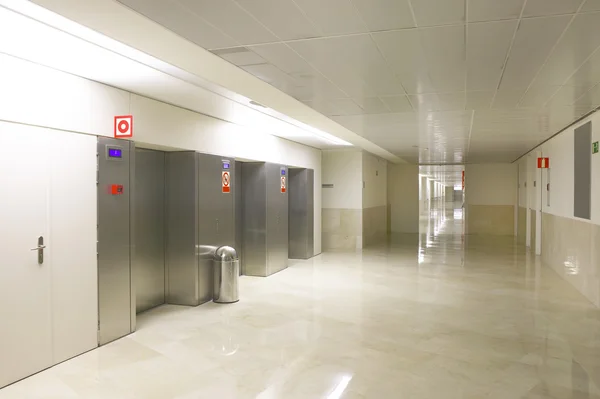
[0,123,52,387]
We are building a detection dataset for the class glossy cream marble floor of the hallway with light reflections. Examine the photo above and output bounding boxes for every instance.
[0,205,600,399]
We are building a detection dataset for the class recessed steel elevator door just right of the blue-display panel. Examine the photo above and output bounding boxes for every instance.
[133,149,165,313]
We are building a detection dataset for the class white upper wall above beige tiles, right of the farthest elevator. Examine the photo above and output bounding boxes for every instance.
[322,150,363,209]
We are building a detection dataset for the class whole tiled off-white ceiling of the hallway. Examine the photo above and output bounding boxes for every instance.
[119,0,600,163]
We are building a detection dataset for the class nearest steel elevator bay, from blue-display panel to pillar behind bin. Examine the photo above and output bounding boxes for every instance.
[98,145,239,344]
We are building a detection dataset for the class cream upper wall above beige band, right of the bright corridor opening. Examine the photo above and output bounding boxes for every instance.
[465,164,518,205]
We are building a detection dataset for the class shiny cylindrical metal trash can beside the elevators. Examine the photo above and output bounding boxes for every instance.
[213,247,240,303]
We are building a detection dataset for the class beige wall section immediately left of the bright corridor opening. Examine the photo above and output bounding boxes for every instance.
[388,163,420,233]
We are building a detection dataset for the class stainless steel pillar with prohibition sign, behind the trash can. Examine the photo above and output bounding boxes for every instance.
[166,152,235,306]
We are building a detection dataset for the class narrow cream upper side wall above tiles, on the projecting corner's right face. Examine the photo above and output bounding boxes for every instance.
[362,151,388,208]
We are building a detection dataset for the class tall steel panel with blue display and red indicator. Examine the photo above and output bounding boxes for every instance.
[98,138,135,344]
